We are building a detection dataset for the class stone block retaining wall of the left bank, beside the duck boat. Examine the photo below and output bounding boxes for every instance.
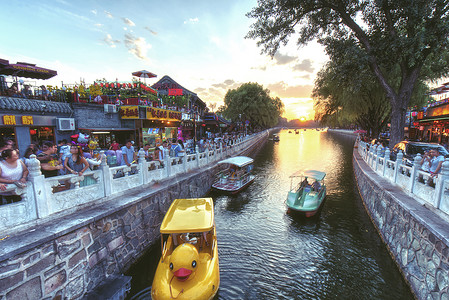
[0,132,266,300]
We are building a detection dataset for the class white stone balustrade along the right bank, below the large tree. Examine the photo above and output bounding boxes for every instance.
[357,141,449,214]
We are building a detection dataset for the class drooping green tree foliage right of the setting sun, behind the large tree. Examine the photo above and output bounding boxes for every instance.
[312,40,428,136]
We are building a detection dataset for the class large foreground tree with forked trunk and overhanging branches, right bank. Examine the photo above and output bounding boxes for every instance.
[247,0,449,145]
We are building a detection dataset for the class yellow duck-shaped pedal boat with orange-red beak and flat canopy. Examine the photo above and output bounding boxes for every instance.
[151,198,220,300]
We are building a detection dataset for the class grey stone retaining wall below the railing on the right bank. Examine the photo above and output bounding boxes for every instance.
[353,146,449,299]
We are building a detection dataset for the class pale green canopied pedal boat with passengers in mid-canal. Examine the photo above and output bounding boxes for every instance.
[286,170,326,217]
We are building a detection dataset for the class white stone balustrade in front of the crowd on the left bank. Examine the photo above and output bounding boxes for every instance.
[0,131,269,230]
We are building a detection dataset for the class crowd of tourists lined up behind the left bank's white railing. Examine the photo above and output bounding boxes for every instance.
[0,133,245,205]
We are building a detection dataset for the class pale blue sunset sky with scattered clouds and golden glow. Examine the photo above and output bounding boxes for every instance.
[0,0,327,119]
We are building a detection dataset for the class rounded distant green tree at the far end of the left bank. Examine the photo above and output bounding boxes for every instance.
[219,83,284,128]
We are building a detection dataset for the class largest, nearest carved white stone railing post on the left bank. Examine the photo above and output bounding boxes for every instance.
[27,154,51,218]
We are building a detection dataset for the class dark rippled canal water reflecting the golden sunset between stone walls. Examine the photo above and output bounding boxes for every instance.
[129,129,413,299]
